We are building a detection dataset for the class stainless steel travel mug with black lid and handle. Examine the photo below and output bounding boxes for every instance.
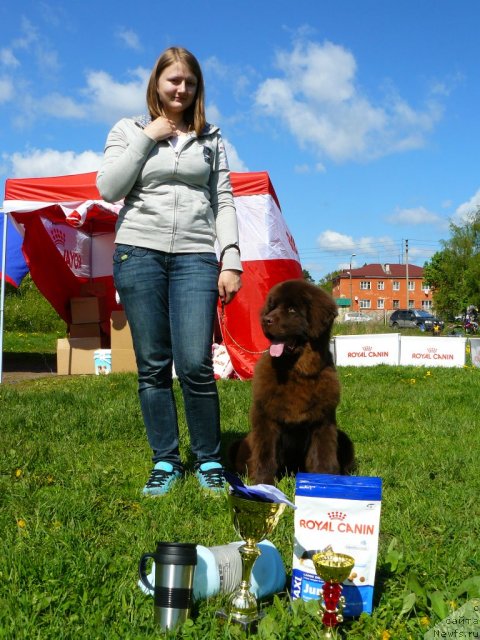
[138,542,197,631]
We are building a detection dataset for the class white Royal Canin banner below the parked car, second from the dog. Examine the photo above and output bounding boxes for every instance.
[400,336,466,367]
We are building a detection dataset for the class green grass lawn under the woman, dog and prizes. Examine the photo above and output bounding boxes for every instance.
[0,366,480,640]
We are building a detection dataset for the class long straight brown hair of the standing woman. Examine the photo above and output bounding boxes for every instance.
[147,47,207,136]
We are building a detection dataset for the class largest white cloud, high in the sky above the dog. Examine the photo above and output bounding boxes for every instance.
[256,41,441,161]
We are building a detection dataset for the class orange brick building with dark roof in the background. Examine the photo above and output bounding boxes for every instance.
[332,264,432,313]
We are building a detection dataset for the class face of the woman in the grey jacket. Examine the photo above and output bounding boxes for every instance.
[157,62,197,117]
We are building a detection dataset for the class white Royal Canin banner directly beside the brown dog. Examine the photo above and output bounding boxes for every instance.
[335,333,400,367]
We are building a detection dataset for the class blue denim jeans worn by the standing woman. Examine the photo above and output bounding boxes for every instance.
[113,244,220,469]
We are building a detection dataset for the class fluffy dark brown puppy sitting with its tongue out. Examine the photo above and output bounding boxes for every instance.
[230,280,354,484]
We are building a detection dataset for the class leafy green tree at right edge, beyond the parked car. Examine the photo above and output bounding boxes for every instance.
[423,208,480,316]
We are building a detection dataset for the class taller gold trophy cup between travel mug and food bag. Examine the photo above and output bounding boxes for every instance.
[218,494,286,630]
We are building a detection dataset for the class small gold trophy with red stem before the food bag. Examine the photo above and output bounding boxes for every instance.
[312,547,355,638]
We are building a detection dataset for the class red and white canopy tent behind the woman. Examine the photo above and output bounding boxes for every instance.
[4,172,302,379]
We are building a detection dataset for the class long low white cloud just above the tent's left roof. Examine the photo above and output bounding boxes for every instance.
[2,149,102,178]
